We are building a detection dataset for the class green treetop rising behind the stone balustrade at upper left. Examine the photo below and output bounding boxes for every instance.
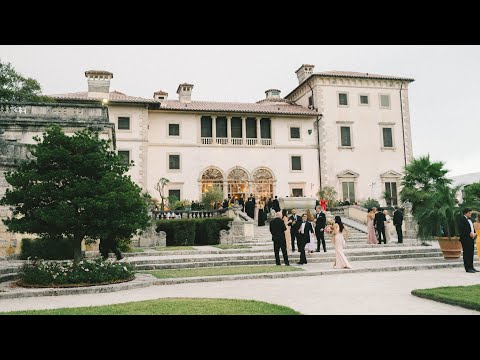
[0,60,53,102]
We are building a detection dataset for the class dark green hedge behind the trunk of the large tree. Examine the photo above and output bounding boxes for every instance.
[20,237,73,260]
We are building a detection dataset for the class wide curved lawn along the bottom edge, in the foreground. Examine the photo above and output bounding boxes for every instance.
[0,298,301,315]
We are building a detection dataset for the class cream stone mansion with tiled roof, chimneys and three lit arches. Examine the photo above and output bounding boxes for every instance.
[53,65,414,205]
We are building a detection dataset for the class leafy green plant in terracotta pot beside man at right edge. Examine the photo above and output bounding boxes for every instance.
[414,184,462,259]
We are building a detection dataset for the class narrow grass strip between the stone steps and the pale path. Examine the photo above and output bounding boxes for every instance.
[145,265,303,279]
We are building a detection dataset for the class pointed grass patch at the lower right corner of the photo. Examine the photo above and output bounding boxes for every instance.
[412,285,480,311]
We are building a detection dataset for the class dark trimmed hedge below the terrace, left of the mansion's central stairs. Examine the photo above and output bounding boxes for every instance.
[157,217,233,246]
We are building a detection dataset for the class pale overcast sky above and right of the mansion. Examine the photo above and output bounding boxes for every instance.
[0,45,480,176]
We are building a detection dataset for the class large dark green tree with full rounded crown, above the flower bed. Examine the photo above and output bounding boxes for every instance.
[0,126,149,262]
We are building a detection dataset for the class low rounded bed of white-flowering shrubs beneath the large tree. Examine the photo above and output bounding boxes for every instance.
[19,258,134,286]
